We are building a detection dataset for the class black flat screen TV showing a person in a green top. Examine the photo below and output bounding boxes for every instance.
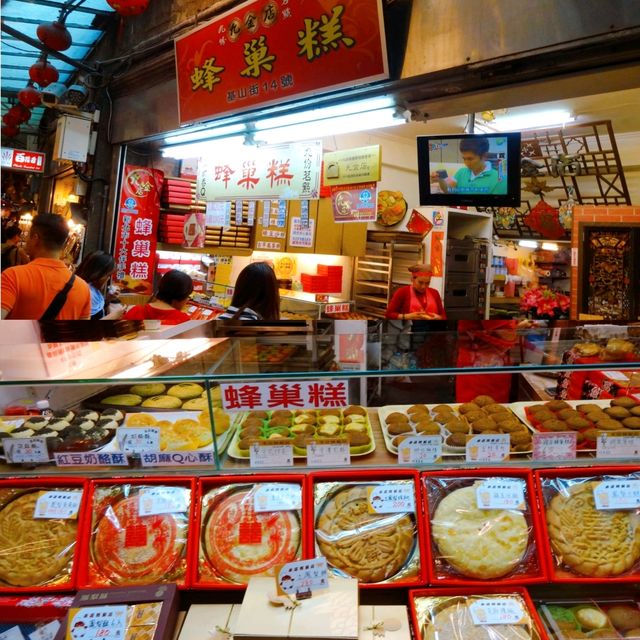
[418,133,520,207]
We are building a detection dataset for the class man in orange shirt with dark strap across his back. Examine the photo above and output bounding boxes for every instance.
[0,213,91,320]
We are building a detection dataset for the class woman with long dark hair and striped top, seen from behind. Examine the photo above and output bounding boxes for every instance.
[217,262,280,320]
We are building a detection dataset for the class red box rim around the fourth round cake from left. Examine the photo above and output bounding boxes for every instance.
[305,469,428,589]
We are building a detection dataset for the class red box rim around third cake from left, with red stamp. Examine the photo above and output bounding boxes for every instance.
[189,474,309,590]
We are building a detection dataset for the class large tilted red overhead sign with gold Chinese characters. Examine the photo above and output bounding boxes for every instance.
[175,0,389,123]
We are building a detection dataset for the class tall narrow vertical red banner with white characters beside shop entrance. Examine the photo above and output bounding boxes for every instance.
[115,164,164,294]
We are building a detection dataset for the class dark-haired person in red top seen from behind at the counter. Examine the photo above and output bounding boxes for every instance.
[124,269,193,324]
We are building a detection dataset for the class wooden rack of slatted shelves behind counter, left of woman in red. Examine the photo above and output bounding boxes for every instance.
[353,231,424,318]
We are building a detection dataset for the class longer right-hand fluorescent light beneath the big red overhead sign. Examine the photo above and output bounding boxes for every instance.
[256,107,405,144]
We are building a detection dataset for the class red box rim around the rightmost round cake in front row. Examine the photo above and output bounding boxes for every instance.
[534,466,640,585]
